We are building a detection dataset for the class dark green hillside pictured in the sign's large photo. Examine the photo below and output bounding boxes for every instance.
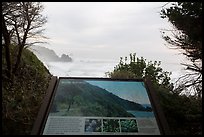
[51,80,149,117]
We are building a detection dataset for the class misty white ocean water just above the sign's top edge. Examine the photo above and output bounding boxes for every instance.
[43,59,119,77]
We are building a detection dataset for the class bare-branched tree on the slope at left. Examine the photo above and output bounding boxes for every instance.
[2,2,47,74]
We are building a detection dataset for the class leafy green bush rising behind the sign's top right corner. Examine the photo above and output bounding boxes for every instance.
[106,53,173,91]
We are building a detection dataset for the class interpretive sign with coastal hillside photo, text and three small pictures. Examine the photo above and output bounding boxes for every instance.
[30,77,171,135]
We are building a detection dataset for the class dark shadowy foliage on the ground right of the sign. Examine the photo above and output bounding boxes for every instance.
[156,88,202,135]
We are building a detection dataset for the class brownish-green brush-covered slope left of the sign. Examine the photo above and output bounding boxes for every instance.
[2,45,51,135]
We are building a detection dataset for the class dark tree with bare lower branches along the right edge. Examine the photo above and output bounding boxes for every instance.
[161,2,202,97]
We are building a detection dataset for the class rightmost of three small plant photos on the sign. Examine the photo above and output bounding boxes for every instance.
[120,119,138,132]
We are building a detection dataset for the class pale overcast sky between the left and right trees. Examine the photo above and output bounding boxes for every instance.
[39,2,190,79]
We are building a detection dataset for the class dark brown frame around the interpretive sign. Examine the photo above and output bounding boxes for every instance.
[31,76,171,135]
